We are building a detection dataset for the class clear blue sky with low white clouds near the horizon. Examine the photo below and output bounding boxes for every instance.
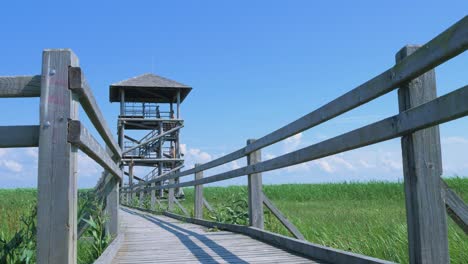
[0,1,468,187]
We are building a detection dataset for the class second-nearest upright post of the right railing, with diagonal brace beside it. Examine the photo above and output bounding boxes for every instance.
[247,139,264,229]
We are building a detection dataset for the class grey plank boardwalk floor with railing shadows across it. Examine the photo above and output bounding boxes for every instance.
[112,208,323,264]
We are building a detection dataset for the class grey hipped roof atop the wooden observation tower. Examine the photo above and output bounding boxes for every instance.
[109,73,192,103]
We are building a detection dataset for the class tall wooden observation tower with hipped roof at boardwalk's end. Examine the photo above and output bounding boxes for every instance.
[109,74,192,197]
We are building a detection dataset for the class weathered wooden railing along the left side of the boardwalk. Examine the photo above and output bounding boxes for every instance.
[0,49,122,263]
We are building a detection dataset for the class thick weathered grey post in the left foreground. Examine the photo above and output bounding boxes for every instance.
[37,49,79,264]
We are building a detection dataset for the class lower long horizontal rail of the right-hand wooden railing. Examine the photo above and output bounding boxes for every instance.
[157,86,468,192]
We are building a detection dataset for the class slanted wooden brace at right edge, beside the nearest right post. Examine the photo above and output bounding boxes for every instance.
[440,179,468,235]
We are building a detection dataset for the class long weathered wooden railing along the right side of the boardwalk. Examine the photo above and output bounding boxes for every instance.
[121,17,468,263]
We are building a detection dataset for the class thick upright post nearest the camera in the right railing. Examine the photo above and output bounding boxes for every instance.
[396,46,449,264]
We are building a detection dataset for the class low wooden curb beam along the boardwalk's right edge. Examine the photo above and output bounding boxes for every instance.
[163,212,393,264]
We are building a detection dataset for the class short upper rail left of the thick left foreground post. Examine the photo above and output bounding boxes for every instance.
[0,75,41,98]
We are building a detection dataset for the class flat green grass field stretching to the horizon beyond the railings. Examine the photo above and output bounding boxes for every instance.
[0,178,468,264]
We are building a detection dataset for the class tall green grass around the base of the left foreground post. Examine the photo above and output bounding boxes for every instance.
[0,189,111,264]
